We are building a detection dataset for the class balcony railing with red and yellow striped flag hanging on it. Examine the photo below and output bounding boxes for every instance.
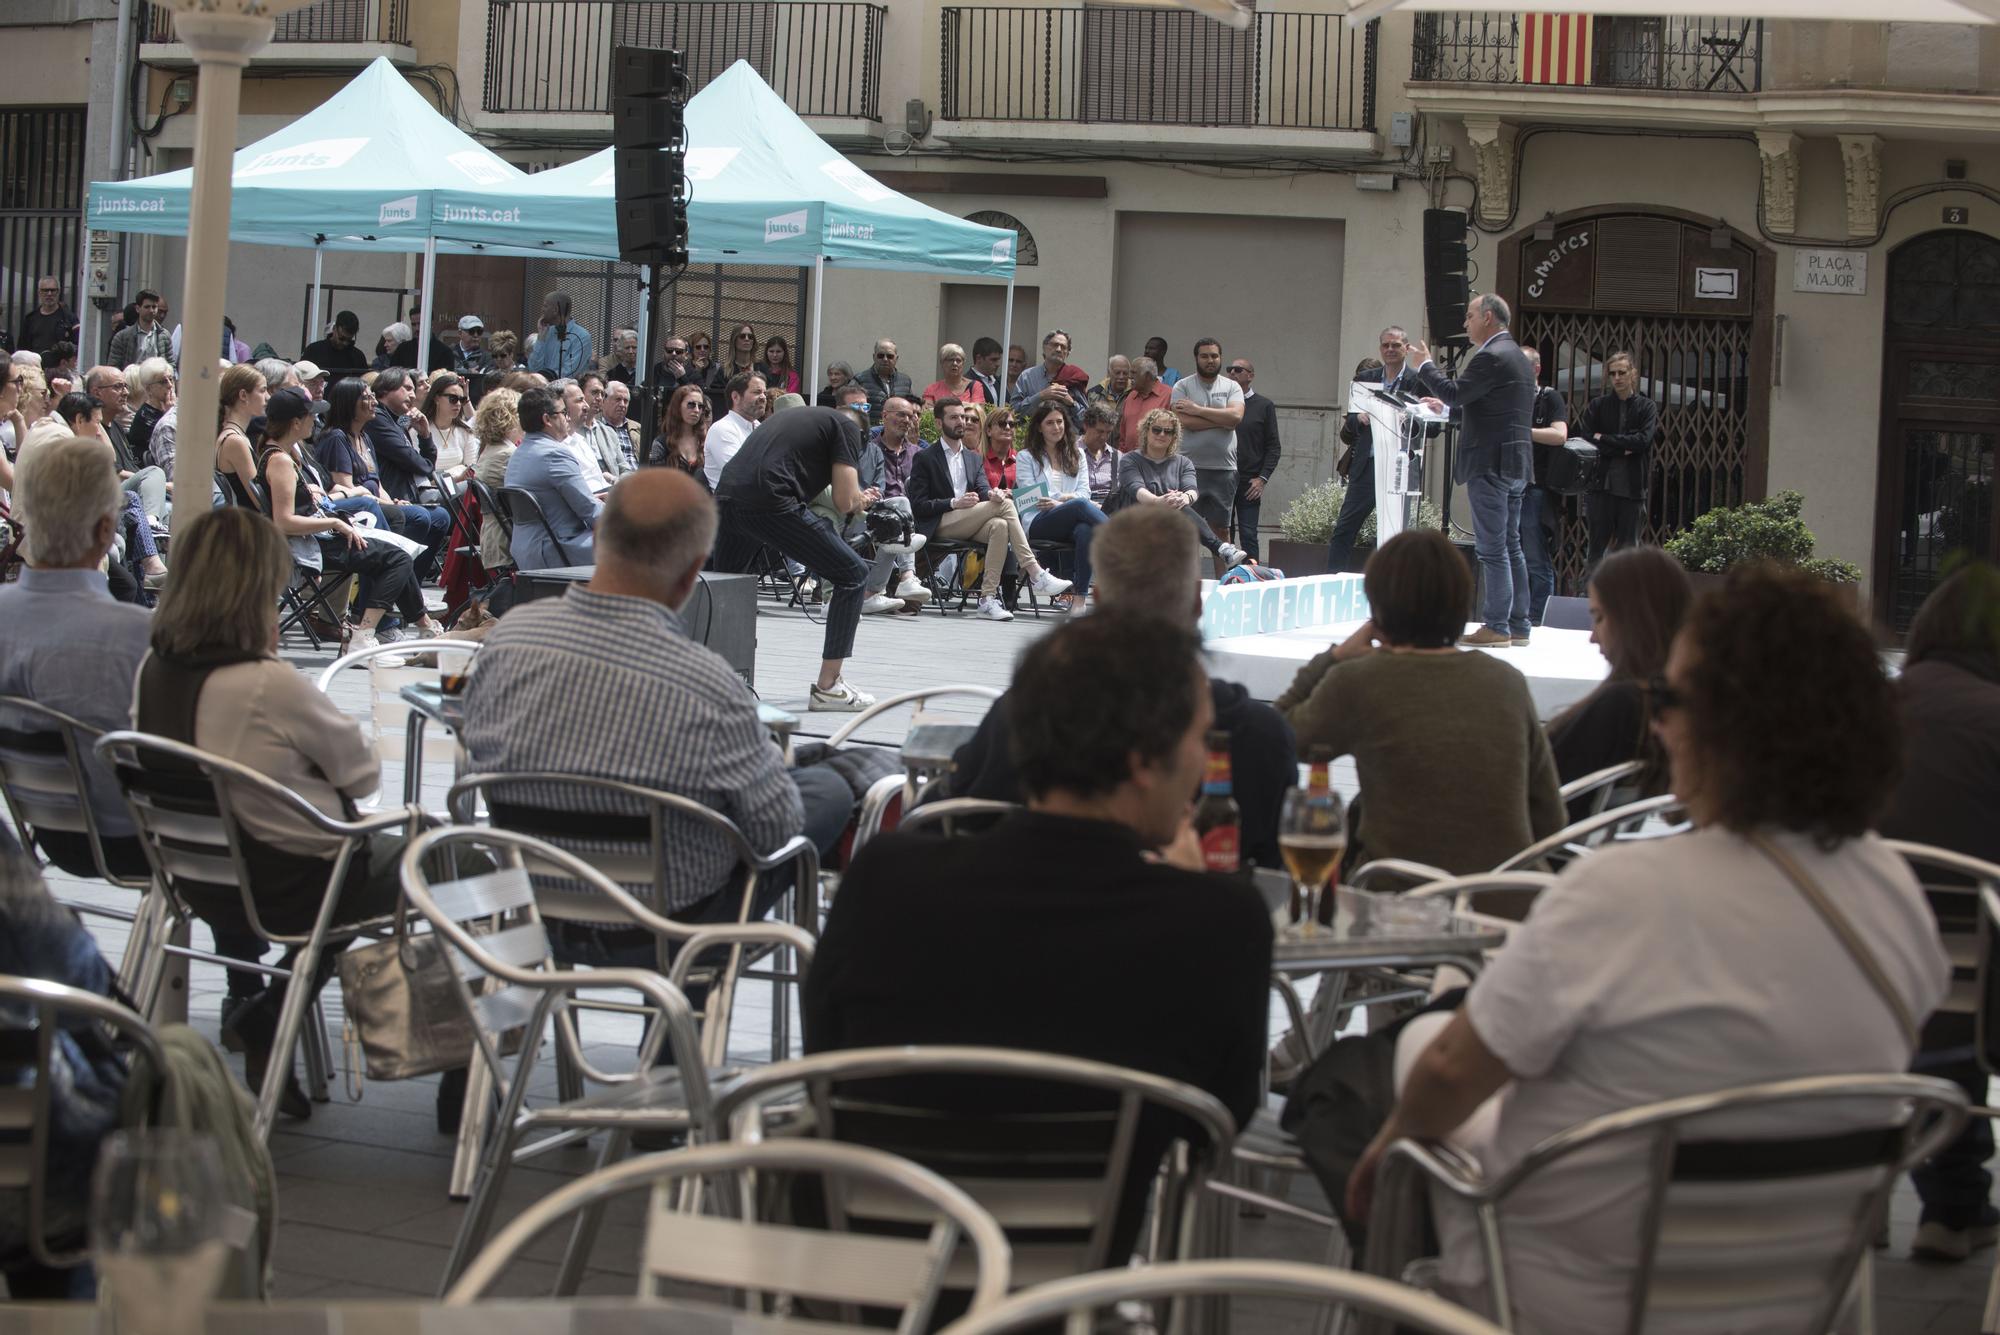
[1410,12,1764,94]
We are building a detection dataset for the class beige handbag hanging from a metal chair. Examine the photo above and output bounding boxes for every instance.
[340,913,476,1097]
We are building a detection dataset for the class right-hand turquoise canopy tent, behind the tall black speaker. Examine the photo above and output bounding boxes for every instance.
[434,60,1014,377]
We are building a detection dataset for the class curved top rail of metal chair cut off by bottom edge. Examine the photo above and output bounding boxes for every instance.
[944,1261,1500,1335]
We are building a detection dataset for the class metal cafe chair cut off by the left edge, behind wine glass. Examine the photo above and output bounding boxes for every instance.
[0,975,168,1269]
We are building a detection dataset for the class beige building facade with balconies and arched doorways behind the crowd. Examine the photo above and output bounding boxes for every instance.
[0,0,2000,611]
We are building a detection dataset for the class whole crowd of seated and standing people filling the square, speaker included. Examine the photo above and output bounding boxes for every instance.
[0,271,2000,1333]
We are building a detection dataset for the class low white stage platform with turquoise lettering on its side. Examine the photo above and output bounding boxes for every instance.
[1202,576,1608,719]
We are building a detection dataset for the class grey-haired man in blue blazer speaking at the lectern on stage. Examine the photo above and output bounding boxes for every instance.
[1408,292,1536,646]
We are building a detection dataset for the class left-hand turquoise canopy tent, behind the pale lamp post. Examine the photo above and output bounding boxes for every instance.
[86,58,530,367]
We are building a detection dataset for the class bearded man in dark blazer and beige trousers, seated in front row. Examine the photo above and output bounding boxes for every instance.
[898,396,1070,622]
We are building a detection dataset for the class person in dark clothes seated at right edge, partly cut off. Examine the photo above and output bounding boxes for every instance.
[1872,552,2000,1261]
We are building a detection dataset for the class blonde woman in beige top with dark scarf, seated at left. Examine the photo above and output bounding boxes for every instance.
[132,506,418,1119]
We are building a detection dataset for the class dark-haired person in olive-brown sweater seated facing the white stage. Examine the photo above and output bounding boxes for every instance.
[1280,531,1564,875]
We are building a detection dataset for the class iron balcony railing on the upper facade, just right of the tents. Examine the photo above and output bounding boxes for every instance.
[942,6,1376,130]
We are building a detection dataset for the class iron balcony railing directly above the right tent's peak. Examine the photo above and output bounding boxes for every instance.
[486,0,888,120]
